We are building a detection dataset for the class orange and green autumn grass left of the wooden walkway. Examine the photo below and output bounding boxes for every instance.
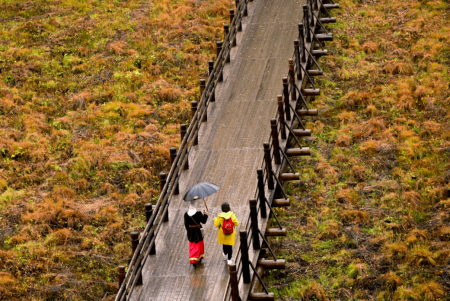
[0,0,230,300]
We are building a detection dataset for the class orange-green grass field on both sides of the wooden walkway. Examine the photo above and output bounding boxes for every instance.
[0,0,450,301]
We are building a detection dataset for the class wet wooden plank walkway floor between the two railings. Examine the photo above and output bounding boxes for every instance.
[131,0,305,301]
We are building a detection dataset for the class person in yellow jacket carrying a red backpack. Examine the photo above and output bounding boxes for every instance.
[214,202,239,265]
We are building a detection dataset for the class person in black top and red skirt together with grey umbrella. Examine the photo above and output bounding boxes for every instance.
[183,182,219,268]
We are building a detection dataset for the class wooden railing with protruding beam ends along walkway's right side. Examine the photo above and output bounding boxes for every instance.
[223,0,339,301]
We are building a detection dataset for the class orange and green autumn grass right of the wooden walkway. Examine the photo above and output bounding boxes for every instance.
[266,0,450,300]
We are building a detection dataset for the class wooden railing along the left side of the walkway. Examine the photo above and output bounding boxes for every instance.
[115,0,252,301]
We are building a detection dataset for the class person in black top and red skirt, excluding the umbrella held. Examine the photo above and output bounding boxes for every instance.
[184,196,208,268]
